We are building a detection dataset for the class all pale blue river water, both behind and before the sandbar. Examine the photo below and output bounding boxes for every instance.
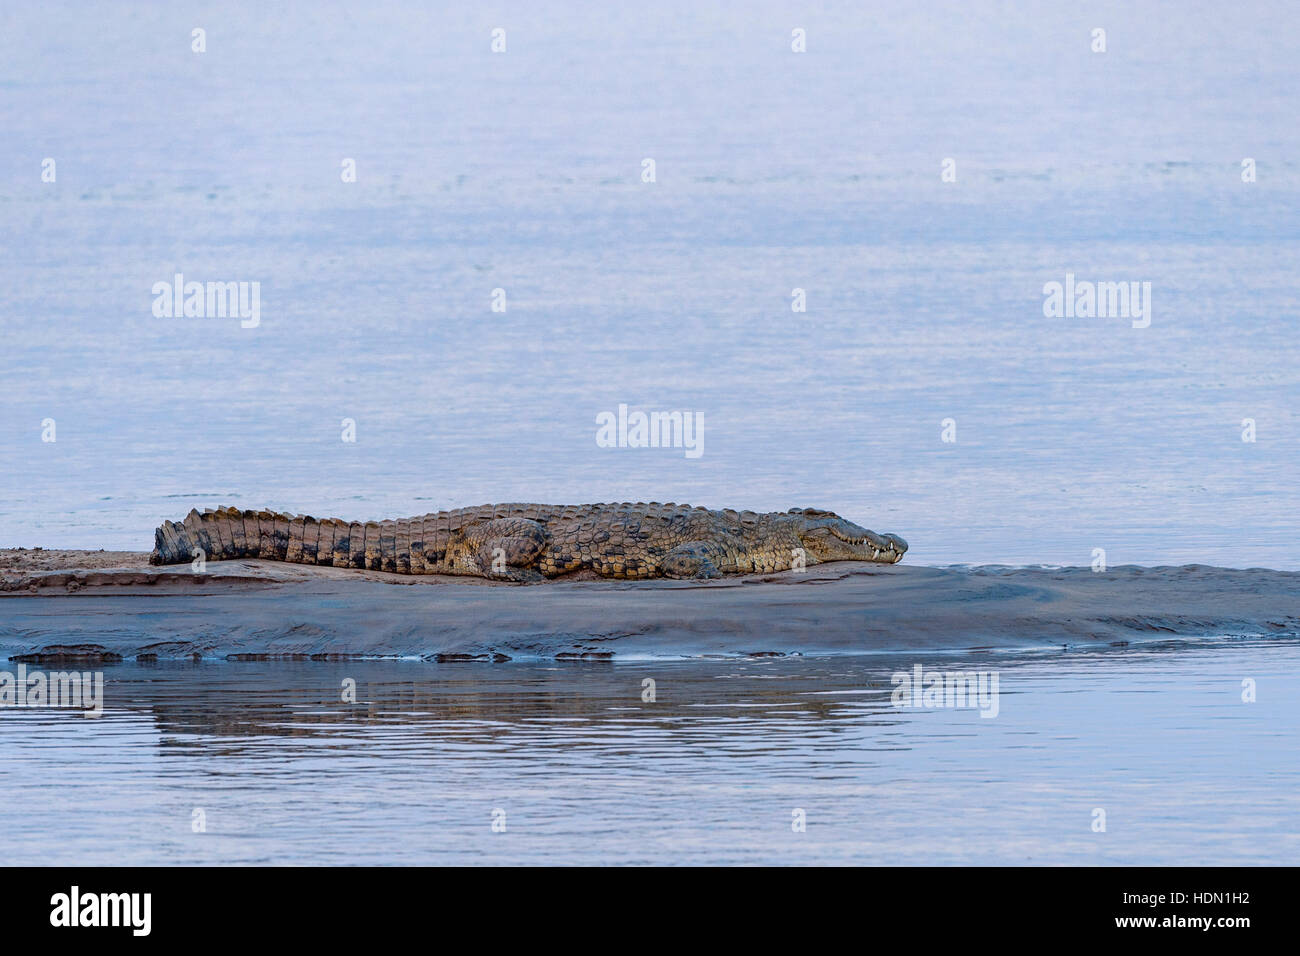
[0,0,1300,864]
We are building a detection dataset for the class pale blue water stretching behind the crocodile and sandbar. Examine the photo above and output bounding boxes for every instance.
[0,1,1300,568]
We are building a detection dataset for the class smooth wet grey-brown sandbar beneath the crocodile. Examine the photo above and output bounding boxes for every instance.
[0,550,1300,662]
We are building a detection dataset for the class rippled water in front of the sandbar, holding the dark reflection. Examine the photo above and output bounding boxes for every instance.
[0,640,1300,864]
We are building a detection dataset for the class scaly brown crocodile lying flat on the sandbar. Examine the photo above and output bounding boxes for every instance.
[150,502,907,583]
